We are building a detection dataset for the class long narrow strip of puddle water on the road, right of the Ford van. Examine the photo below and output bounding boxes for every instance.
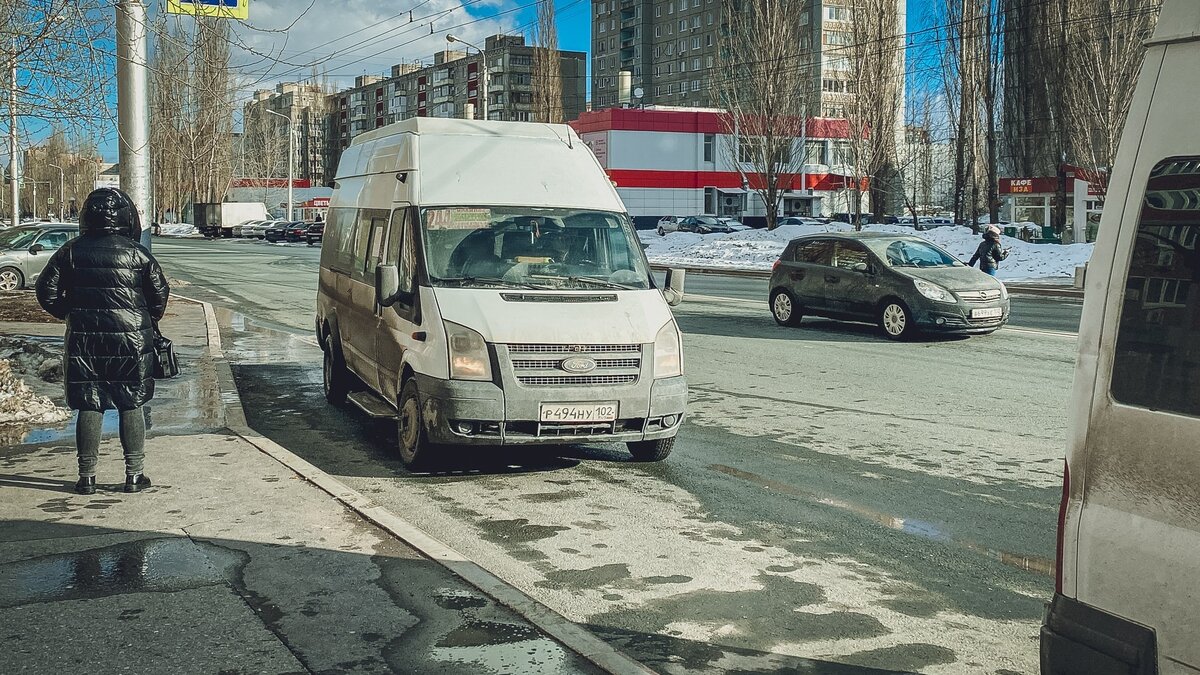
[708,464,1055,577]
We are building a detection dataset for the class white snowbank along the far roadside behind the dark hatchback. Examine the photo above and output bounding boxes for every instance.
[638,222,1094,281]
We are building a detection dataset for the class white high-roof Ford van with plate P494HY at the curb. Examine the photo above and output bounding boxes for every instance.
[316,118,688,466]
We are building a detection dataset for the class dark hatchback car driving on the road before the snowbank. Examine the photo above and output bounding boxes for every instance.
[769,232,1008,340]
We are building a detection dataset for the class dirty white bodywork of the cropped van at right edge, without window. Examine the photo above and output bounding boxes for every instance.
[1043,9,1200,674]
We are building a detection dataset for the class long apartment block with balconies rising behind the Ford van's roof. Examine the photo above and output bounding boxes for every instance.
[329,35,587,175]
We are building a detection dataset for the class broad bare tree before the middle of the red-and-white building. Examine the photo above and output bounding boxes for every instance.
[712,0,809,229]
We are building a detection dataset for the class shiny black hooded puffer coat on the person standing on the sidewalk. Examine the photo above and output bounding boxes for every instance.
[37,187,170,411]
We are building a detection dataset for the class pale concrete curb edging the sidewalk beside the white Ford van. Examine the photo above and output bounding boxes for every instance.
[175,295,655,675]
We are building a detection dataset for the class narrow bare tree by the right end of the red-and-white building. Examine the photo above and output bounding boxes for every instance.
[833,0,904,227]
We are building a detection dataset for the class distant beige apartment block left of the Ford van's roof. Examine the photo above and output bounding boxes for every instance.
[241,82,332,185]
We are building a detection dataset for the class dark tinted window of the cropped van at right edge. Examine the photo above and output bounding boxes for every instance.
[1111,157,1200,417]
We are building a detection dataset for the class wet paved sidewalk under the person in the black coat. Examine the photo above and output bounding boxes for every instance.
[0,300,602,675]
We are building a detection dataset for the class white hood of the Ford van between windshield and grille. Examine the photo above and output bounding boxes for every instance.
[437,288,674,345]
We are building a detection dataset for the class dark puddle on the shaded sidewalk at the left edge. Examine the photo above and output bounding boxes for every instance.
[0,537,242,608]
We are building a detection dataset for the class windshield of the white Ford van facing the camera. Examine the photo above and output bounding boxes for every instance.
[421,207,652,289]
